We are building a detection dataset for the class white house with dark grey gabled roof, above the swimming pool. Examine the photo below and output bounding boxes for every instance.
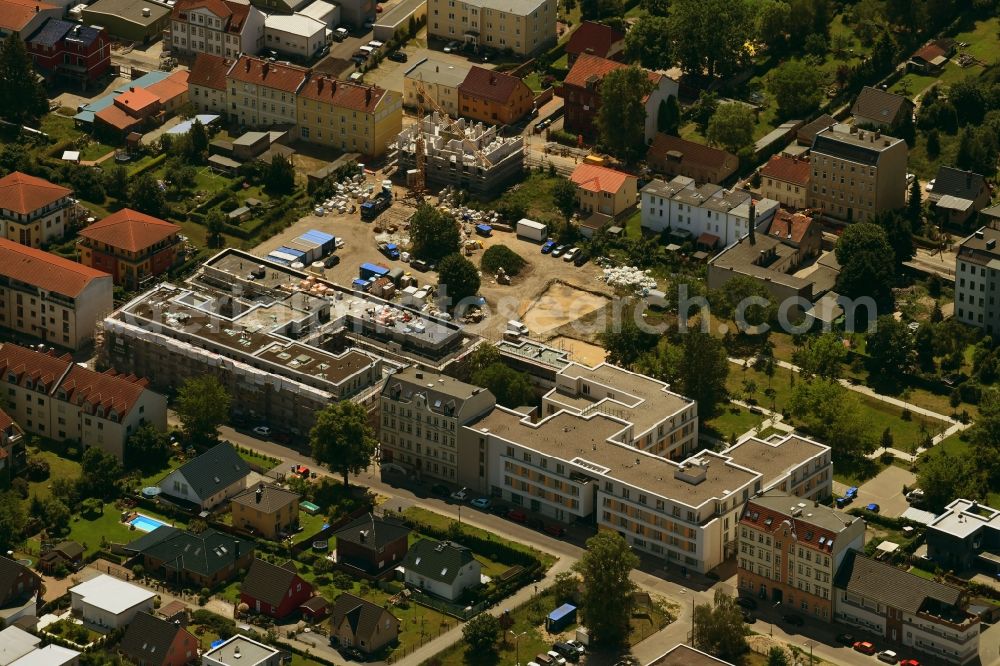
[159,442,250,511]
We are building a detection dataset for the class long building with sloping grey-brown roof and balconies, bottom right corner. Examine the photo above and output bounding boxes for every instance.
[833,551,980,664]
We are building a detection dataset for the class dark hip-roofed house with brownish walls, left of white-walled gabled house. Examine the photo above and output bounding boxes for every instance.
[334,515,410,575]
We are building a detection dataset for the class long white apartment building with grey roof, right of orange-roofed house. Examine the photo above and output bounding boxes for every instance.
[640,176,779,247]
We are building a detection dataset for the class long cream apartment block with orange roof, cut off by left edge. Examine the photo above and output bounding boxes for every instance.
[0,239,114,350]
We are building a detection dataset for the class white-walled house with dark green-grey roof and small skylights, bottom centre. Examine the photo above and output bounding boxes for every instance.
[403,539,482,601]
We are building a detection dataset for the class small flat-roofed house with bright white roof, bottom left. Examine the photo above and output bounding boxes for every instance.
[69,574,156,632]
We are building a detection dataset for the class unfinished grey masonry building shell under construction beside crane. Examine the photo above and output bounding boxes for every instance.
[389,111,524,199]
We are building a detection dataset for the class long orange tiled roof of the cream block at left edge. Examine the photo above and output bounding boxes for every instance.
[0,238,111,298]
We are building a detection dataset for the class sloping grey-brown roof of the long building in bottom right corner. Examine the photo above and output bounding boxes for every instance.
[834,550,963,613]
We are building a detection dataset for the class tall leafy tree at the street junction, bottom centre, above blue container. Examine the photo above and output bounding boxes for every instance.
[573,532,639,645]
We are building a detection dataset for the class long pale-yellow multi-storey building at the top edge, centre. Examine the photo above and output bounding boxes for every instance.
[427,0,558,56]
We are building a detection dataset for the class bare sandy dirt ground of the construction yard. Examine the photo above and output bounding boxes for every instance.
[254,178,612,344]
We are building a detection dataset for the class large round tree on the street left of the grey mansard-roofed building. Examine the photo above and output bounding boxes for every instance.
[309,400,377,488]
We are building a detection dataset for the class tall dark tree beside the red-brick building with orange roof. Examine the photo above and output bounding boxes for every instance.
[595,67,653,163]
